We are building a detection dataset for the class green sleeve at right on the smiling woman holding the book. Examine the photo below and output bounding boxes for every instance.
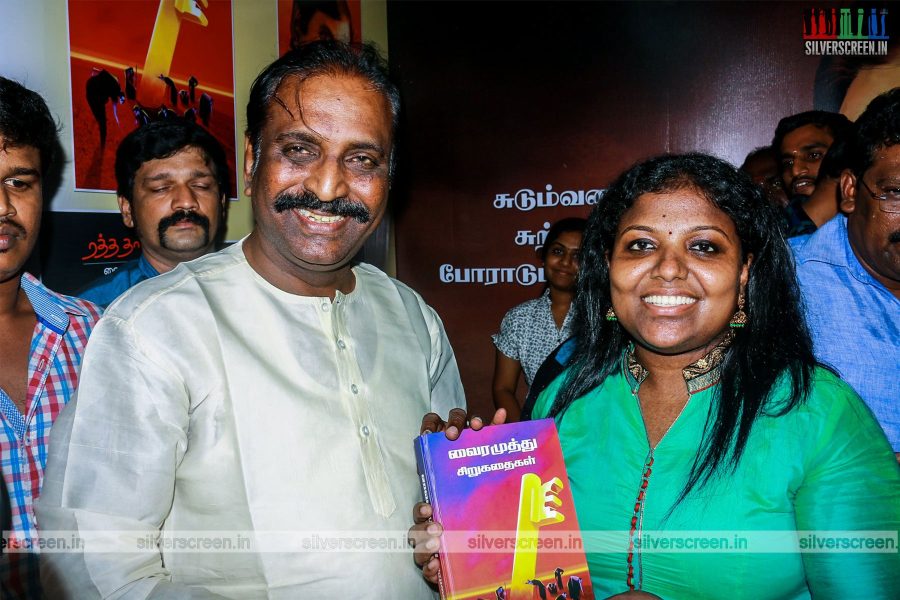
[785,372,900,599]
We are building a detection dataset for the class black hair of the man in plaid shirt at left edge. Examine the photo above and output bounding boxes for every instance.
[0,77,59,175]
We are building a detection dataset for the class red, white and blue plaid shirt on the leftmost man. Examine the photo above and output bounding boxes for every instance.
[0,273,100,598]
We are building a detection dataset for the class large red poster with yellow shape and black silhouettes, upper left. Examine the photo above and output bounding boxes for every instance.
[68,0,237,198]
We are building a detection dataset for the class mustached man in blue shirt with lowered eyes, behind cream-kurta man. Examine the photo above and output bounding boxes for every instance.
[78,119,228,308]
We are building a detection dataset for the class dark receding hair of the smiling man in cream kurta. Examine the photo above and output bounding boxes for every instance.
[246,40,400,173]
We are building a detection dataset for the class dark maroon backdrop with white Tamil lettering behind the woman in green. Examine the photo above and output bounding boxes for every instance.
[388,1,819,413]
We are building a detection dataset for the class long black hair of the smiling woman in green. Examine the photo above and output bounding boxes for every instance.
[550,154,816,502]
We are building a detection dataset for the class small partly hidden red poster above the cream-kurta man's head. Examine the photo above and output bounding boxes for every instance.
[278,0,362,55]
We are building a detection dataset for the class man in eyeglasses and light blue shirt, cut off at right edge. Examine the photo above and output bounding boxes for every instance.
[790,88,900,460]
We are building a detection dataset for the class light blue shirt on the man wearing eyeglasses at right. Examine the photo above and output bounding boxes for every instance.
[790,215,900,452]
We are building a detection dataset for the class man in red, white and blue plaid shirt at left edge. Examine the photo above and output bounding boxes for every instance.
[0,77,100,598]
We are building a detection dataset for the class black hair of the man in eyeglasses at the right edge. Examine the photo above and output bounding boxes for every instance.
[849,87,900,178]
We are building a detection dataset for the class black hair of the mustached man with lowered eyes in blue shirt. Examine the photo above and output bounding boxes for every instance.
[116,118,230,202]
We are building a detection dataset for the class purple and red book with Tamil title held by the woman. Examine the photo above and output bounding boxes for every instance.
[415,419,594,600]
